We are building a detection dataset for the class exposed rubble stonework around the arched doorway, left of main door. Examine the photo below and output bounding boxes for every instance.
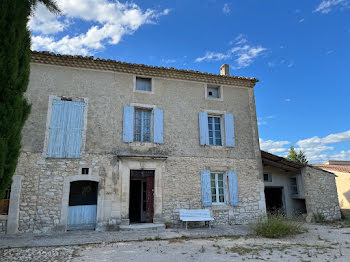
[16,153,117,233]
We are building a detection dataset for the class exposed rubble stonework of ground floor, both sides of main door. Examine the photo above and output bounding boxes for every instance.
[16,152,266,233]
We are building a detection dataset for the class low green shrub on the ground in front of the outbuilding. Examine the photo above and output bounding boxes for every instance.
[252,212,306,238]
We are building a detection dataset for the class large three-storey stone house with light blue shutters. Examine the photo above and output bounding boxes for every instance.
[0,52,340,233]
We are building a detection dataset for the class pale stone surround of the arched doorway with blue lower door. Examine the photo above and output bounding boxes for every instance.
[58,175,104,231]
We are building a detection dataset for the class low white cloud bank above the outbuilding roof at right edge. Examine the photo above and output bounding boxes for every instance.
[260,130,350,163]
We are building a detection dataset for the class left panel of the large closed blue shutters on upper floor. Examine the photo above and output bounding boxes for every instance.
[47,100,66,158]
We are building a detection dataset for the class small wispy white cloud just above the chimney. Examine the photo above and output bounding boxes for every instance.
[195,34,266,69]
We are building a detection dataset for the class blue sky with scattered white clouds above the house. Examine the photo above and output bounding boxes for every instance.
[29,0,350,163]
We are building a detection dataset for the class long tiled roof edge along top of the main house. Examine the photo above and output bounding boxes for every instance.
[31,51,259,87]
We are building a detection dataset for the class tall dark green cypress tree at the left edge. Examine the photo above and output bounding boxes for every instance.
[0,0,59,196]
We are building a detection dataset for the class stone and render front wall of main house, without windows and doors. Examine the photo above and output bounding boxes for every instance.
[3,56,266,233]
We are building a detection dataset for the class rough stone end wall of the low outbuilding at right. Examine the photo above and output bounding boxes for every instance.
[302,166,341,221]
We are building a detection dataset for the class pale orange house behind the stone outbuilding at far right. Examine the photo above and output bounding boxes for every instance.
[313,160,350,217]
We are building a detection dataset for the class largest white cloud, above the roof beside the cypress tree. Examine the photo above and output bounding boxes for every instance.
[29,0,170,55]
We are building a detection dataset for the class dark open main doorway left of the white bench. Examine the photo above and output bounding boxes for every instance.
[129,170,154,223]
